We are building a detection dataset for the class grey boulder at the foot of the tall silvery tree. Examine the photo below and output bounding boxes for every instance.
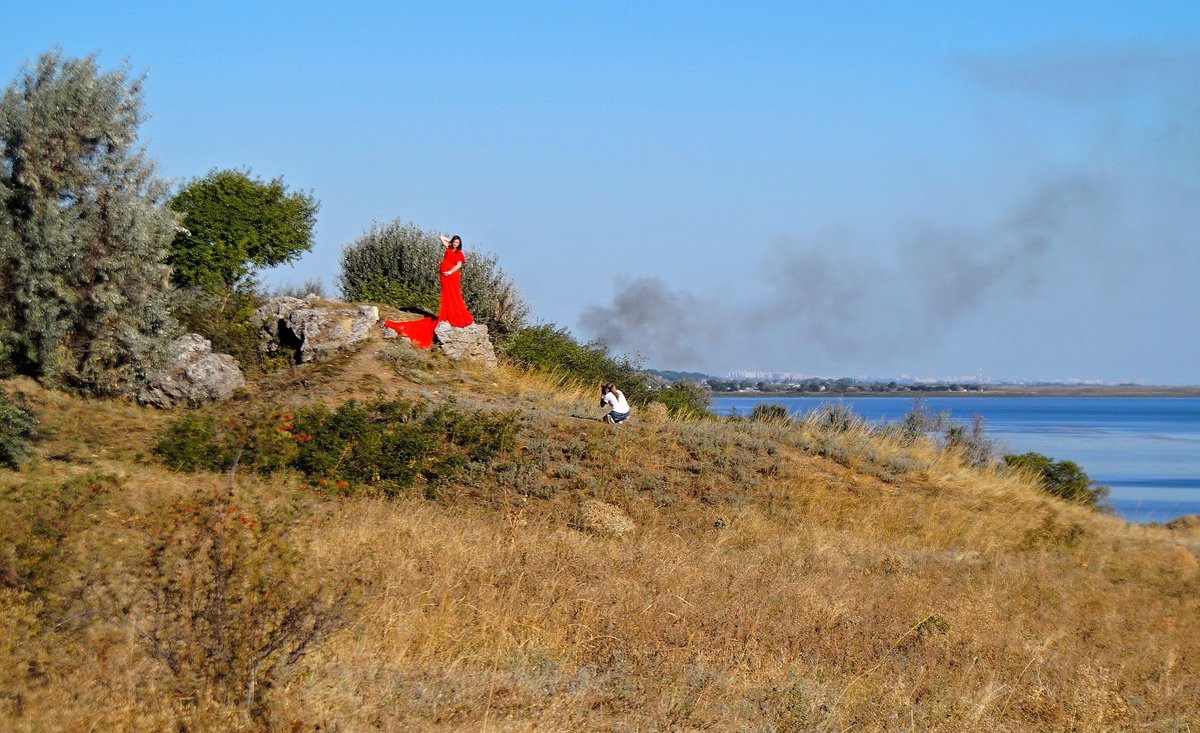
[138,334,246,408]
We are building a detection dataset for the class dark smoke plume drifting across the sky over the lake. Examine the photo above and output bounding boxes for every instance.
[581,42,1200,368]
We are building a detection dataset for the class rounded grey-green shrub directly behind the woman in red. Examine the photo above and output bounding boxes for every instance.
[338,220,529,342]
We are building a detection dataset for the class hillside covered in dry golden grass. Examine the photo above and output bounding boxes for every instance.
[0,328,1200,732]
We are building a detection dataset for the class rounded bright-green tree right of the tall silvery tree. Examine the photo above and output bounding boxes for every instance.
[168,170,320,293]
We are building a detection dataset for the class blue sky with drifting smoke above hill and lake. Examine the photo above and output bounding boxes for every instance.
[9,1,1200,384]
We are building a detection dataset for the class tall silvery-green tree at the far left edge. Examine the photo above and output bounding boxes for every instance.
[0,52,176,393]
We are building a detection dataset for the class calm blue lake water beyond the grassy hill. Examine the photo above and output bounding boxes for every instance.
[710,396,1200,522]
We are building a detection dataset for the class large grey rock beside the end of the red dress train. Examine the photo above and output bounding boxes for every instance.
[254,298,379,364]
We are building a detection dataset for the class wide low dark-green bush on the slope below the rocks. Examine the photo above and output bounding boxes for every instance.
[155,399,518,495]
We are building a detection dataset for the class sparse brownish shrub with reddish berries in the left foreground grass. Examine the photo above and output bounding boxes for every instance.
[137,488,364,720]
